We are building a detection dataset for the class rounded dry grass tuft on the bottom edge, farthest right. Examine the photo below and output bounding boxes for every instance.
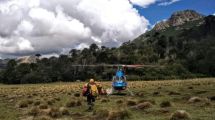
[170,110,191,120]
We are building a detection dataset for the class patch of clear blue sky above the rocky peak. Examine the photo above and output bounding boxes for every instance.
[134,0,215,25]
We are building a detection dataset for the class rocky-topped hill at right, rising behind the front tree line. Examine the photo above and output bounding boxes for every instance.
[132,10,215,76]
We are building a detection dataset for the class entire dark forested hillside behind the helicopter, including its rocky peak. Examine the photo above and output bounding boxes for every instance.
[0,10,215,84]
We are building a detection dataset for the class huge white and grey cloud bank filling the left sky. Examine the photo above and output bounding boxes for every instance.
[0,0,149,58]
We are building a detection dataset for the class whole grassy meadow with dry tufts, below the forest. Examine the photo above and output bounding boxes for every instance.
[0,78,215,120]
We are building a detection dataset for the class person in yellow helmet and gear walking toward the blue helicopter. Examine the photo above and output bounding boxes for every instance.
[83,79,99,110]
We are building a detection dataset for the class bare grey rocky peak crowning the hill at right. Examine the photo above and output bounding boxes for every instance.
[153,10,204,30]
